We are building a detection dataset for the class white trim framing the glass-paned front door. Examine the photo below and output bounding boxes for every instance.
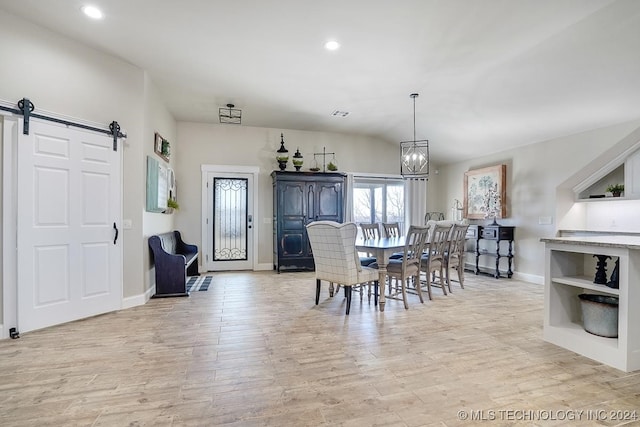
[200,165,260,271]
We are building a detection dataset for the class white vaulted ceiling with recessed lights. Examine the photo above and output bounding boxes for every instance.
[0,0,640,163]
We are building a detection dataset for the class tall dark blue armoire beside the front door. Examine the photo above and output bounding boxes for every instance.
[271,171,346,272]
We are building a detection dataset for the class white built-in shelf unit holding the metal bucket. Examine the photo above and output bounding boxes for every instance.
[542,236,640,372]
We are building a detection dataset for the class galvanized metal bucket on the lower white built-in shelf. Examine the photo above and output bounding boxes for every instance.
[578,294,618,338]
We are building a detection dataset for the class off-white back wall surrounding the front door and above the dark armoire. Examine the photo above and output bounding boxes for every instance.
[176,122,400,265]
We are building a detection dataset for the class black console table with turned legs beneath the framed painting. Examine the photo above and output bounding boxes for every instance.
[467,225,515,279]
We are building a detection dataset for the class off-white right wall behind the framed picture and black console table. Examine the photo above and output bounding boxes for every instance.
[430,121,640,283]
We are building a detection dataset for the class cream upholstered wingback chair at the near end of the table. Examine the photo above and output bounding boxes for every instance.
[307,221,379,315]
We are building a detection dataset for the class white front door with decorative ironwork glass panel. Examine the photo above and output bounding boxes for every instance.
[204,172,254,271]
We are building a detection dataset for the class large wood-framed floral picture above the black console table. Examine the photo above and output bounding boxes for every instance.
[463,165,507,219]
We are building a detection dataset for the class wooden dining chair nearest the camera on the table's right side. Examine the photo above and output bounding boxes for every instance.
[383,225,429,309]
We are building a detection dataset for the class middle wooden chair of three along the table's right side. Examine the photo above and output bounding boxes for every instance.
[420,221,453,299]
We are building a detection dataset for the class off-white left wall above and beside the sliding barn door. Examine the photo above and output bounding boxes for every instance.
[0,11,177,310]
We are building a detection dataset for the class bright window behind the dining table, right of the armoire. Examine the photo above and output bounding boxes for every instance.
[353,176,405,237]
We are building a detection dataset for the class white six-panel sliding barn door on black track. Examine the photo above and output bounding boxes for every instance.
[17,119,122,332]
